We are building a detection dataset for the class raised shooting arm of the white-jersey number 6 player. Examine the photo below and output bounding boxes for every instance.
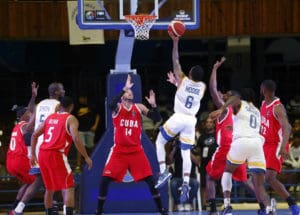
[168,31,184,85]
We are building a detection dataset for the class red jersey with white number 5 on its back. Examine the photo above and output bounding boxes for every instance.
[40,112,72,155]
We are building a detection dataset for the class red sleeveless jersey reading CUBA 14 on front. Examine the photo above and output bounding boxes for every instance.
[113,104,142,153]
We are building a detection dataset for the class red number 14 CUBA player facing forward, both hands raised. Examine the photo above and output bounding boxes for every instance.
[96,75,167,215]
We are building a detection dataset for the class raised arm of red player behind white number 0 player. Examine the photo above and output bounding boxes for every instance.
[209,57,226,108]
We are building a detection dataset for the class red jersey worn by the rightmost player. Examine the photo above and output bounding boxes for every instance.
[260,98,282,145]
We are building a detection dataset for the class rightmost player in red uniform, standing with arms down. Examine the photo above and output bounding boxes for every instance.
[260,80,300,215]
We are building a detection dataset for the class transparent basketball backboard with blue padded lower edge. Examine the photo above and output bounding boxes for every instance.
[77,0,200,30]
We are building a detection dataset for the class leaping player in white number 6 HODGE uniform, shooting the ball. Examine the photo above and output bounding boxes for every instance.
[156,32,206,203]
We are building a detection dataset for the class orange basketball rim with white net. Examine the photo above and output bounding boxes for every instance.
[125,14,156,40]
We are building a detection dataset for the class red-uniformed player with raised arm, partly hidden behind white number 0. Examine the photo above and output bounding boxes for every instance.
[206,57,253,215]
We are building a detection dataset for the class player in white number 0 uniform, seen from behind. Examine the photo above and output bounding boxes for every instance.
[210,88,272,215]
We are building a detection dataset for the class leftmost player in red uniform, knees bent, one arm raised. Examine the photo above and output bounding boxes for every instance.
[6,82,41,215]
